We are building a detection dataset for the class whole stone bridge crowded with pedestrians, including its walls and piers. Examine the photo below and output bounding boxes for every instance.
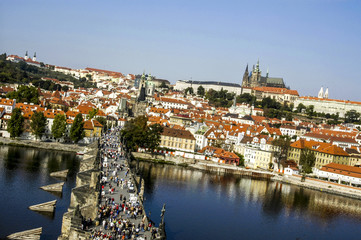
[58,126,165,240]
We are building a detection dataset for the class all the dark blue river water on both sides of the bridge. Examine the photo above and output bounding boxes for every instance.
[0,146,361,240]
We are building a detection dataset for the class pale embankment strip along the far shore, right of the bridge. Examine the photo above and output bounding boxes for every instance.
[132,152,361,200]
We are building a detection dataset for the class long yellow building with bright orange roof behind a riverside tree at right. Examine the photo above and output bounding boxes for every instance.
[288,139,351,169]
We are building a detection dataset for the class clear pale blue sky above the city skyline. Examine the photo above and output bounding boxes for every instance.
[0,0,361,101]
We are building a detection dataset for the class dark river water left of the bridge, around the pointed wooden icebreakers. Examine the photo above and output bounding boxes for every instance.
[0,146,79,239]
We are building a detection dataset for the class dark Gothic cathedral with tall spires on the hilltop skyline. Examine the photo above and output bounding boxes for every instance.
[242,61,285,88]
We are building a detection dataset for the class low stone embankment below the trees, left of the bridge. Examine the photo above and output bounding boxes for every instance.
[0,137,86,152]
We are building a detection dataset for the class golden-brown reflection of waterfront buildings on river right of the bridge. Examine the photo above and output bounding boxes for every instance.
[140,162,361,223]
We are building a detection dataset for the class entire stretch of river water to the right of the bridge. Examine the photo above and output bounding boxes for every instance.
[140,162,361,240]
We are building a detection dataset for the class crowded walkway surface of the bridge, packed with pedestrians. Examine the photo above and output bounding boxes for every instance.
[90,130,159,240]
